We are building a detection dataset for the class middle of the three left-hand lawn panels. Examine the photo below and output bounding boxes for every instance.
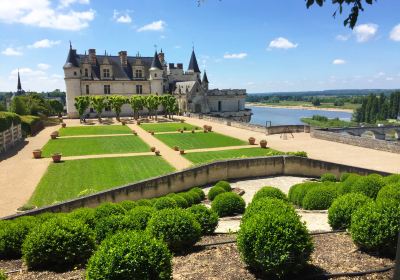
[43,135,149,157]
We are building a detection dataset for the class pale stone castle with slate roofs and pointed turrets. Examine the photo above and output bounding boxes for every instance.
[63,45,251,122]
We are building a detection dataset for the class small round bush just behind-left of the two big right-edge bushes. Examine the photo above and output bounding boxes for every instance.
[302,185,338,210]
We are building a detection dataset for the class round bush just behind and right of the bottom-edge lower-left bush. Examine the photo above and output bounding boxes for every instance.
[146,208,201,252]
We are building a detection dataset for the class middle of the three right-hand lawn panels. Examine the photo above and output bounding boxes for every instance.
[154,132,247,150]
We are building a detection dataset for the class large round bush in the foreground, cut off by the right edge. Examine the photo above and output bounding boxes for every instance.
[350,200,400,256]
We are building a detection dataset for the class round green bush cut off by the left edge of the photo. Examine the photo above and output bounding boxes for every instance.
[0,216,36,259]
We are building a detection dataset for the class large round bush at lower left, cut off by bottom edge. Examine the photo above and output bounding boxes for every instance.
[86,231,172,280]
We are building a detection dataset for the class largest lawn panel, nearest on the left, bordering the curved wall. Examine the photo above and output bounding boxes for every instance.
[29,156,174,206]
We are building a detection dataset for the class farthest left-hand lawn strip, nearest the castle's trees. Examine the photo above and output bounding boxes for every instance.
[59,125,132,136]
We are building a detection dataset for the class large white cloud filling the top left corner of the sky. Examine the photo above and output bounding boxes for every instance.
[0,0,95,31]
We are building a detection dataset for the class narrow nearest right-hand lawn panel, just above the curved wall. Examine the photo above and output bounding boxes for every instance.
[184,148,284,164]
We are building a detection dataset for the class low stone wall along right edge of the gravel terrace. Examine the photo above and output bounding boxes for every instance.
[310,129,400,154]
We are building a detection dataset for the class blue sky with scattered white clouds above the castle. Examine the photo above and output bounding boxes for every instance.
[0,0,400,93]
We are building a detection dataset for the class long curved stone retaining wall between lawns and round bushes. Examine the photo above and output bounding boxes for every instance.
[3,156,388,219]
